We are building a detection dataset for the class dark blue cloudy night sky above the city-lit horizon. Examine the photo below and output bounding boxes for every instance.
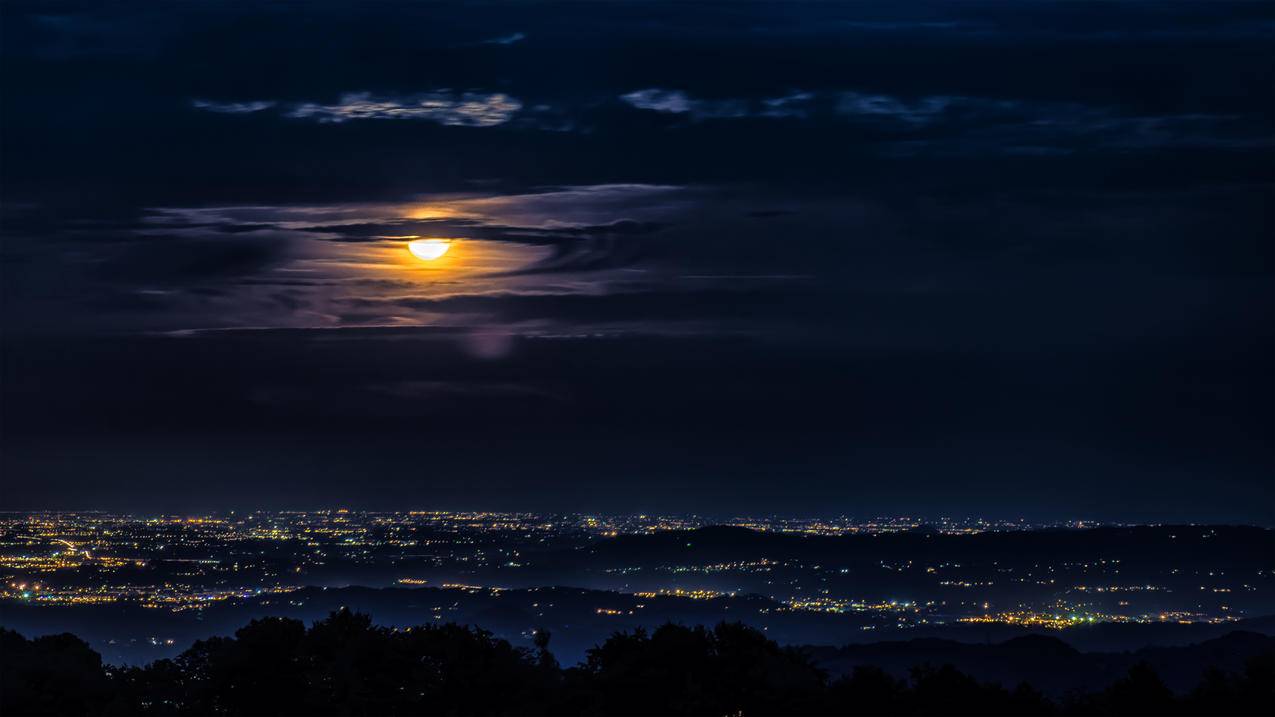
[0,0,1275,523]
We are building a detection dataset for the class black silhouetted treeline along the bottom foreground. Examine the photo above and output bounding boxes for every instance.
[0,610,1275,716]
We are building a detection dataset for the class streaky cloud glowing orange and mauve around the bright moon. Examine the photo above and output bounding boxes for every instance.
[103,184,709,330]
